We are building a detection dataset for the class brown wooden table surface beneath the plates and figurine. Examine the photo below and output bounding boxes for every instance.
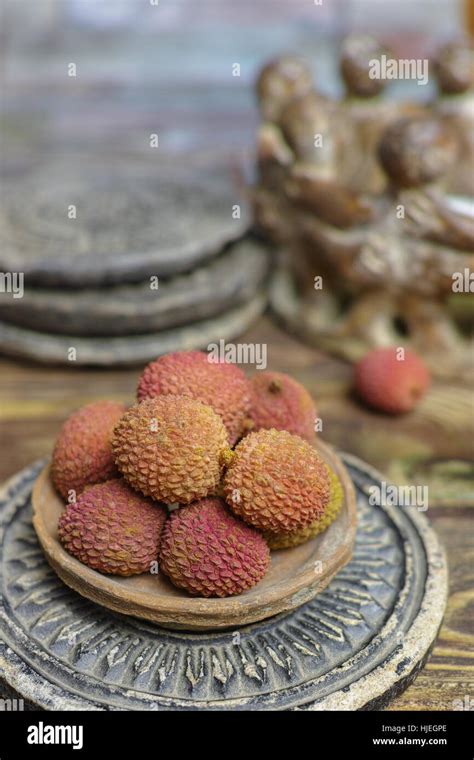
[0,316,474,710]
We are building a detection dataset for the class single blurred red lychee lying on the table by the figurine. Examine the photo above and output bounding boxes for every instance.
[354,347,431,414]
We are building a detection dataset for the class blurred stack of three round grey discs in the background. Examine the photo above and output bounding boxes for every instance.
[0,159,268,365]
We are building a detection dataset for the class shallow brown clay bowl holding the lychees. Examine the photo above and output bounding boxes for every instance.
[32,441,356,630]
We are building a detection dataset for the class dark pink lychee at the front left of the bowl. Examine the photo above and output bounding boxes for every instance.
[58,478,166,576]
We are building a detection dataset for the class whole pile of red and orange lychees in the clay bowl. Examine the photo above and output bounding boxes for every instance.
[51,351,343,597]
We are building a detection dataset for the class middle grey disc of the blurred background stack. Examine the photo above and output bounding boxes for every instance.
[0,240,268,336]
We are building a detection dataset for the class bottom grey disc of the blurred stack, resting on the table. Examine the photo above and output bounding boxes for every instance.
[0,291,266,367]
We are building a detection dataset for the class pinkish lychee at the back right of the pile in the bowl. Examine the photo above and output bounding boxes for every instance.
[249,372,317,442]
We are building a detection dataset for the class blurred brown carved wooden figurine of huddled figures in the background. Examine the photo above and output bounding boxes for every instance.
[254,41,474,374]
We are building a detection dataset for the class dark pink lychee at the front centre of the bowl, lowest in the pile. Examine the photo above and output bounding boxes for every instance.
[160,498,270,597]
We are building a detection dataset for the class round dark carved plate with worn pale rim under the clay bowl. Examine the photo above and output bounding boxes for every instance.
[0,455,447,710]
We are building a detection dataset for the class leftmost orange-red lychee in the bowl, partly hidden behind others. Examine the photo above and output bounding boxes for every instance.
[51,401,125,500]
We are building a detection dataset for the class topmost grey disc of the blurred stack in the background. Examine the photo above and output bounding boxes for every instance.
[0,158,252,287]
